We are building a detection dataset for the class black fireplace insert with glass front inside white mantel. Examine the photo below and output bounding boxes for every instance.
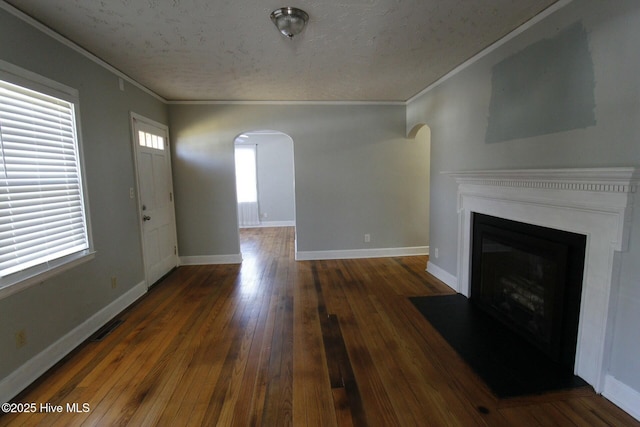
[470,213,586,371]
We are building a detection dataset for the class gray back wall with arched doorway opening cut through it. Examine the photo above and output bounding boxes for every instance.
[170,104,429,256]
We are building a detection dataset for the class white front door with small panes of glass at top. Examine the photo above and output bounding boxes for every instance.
[131,114,178,286]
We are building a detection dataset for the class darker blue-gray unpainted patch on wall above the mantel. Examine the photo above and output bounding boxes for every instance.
[485,22,596,143]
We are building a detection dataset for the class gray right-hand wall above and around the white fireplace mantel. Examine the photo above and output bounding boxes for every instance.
[407,0,640,390]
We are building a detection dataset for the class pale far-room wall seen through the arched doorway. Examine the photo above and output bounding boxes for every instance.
[237,132,296,223]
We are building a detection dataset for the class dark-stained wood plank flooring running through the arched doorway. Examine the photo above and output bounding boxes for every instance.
[0,228,640,427]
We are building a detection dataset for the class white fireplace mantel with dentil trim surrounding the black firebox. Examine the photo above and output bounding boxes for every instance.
[444,167,639,392]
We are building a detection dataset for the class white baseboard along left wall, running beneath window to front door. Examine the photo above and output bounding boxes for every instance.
[0,281,147,403]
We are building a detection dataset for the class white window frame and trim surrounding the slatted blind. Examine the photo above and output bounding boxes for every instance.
[0,60,95,299]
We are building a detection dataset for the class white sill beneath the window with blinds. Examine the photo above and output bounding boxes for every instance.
[0,250,96,300]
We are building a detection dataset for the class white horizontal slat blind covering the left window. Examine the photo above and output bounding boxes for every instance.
[0,80,89,277]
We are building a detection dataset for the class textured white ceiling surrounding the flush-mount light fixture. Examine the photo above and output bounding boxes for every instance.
[7,0,556,101]
